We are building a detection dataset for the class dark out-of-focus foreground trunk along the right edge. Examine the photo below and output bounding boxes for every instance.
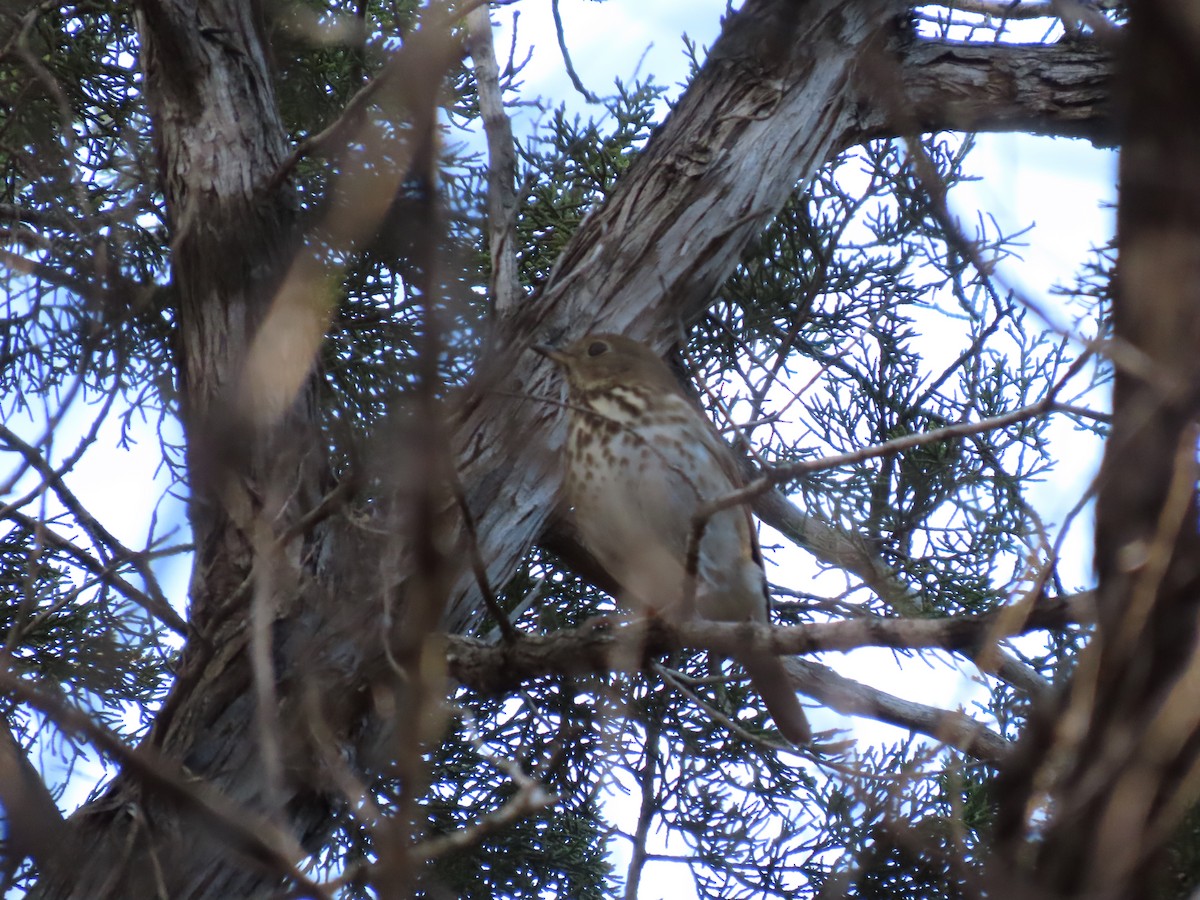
[1001,0,1200,900]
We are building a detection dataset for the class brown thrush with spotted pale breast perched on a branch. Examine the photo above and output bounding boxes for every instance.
[534,334,811,745]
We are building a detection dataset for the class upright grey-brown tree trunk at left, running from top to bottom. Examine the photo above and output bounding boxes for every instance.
[34,0,326,900]
